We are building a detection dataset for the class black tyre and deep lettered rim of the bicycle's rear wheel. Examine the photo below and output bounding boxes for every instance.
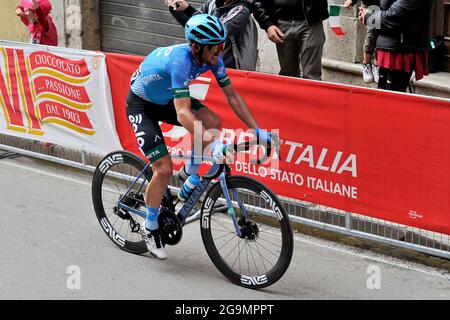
[91,151,152,254]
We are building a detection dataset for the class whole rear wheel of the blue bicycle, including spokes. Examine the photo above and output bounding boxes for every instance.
[92,151,152,254]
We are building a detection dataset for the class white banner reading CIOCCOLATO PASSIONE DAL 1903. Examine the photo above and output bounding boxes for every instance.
[0,42,122,153]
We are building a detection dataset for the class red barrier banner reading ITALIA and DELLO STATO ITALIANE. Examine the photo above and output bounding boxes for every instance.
[107,54,450,234]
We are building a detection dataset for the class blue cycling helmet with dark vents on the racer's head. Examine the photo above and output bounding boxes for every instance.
[185,14,228,45]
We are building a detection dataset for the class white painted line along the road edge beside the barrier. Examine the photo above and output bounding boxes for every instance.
[0,161,450,281]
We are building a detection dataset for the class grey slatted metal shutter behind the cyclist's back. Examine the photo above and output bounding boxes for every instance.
[100,0,203,56]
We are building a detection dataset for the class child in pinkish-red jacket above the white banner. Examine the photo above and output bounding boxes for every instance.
[16,0,58,46]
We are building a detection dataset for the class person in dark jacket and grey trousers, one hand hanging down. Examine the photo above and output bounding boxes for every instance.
[253,0,329,80]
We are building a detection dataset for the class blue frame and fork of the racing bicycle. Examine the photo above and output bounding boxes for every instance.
[117,163,247,237]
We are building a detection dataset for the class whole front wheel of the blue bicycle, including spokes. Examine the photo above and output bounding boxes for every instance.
[200,176,294,289]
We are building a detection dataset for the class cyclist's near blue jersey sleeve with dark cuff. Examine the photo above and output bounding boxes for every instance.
[166,56,191,99]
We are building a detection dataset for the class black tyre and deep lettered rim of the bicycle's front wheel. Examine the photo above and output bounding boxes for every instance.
[200,176,294,289]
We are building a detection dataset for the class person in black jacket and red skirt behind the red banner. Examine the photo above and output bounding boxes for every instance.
[359,0,433,92]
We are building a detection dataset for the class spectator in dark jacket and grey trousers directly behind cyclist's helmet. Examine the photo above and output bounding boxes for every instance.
[167,0,258,71]
